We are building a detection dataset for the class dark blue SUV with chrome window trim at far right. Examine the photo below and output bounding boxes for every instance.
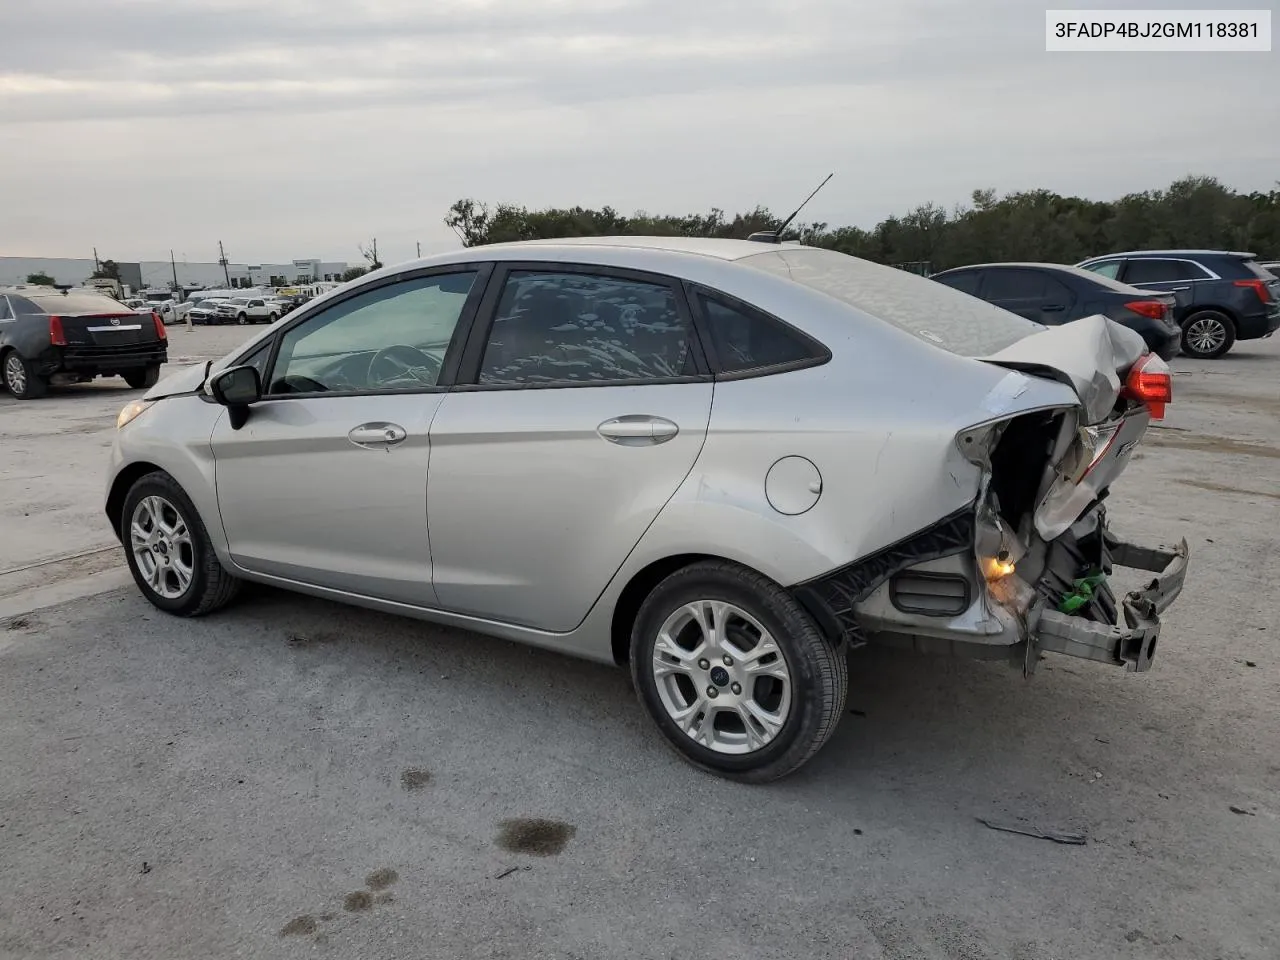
[1078,250,1280,360]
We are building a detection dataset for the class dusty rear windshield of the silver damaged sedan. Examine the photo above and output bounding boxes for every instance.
[737,247,1044,357]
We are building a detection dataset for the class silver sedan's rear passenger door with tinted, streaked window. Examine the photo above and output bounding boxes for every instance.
[426,264,713,632]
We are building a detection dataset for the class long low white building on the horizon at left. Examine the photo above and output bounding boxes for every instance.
[0,257,351,291]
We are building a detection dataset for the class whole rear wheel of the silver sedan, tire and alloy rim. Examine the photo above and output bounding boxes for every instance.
[631,562,849,783]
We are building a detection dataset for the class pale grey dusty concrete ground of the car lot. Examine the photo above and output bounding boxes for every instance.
[0,329,1280,960]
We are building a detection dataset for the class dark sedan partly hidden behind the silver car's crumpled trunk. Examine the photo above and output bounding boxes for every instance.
[931,264,1181,360]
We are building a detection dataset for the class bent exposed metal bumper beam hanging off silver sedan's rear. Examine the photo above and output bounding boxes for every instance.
[1028,540,1189,671]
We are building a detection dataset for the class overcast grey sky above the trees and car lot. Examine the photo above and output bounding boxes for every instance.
[0,0,1280,262]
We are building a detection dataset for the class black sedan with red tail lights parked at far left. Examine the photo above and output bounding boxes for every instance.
[0,287,169,399]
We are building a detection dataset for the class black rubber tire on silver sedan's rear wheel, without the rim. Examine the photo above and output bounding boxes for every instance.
[631,561,849,783]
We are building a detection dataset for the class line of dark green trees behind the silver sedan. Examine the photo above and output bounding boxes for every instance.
[444,177,1280,271]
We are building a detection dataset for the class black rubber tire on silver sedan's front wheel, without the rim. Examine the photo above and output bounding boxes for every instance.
[119,470,242,617]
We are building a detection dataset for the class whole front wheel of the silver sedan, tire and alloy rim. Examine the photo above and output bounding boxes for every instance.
[120,470,241,617]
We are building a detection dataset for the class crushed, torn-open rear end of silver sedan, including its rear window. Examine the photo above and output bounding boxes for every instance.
[758,251,1188,675]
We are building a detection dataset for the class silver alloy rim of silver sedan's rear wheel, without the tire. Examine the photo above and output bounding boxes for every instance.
[653,600,792,754]
